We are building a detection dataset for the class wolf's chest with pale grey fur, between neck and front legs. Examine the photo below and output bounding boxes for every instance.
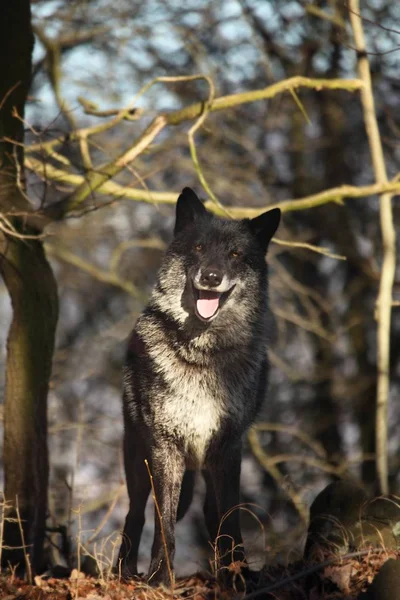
[124,314,265,467]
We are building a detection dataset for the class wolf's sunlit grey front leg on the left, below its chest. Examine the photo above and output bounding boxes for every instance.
[148,444,185,586]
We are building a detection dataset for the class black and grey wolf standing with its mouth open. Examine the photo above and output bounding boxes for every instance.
[119,188,280,585]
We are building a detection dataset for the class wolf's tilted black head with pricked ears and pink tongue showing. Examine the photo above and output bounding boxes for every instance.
[152,188,280,324]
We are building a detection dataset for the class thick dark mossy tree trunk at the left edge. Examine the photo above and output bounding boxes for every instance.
[0,0,58,571]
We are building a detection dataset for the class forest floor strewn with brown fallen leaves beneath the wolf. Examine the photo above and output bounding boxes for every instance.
[0,549,400,600]
